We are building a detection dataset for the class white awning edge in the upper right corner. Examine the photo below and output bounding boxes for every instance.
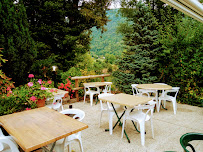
[161,0,203,23]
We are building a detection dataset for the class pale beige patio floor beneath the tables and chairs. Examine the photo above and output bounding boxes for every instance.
[64,101,203,152]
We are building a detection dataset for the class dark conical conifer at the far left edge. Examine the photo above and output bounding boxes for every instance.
[0,0,37,85]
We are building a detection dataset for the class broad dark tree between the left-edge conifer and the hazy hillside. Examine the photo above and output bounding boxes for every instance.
[23,0,112,76]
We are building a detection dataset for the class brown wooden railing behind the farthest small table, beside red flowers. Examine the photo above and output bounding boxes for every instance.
[71,74,110,102]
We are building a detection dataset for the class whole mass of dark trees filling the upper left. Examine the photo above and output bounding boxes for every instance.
[0,0,111,84]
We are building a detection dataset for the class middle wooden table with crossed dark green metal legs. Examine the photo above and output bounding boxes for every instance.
[99,93,152,143]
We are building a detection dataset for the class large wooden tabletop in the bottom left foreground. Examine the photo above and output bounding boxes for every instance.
[0,107,88,152]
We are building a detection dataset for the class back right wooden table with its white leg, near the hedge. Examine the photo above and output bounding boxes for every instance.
[136,84,172,112]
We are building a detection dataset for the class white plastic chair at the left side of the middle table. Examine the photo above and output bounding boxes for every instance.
[98,93,123,135]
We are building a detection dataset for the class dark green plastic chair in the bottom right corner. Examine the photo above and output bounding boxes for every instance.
[180,132,203,152]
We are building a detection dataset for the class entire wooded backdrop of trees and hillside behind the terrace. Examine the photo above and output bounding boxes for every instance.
[0,0,203,114]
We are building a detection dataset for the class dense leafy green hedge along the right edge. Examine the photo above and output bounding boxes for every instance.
[159,17,203,106]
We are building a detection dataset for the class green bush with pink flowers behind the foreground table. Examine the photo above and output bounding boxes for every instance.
[0,74,54,115]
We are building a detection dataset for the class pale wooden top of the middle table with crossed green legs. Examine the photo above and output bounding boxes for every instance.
[99,93,152,107]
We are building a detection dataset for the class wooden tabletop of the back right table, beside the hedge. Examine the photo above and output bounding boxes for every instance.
[136,84,172,90]
